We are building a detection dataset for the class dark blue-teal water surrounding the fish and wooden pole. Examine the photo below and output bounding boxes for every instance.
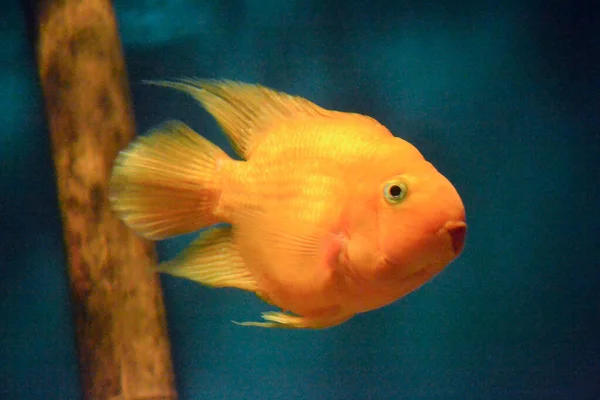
[0,0,600,400]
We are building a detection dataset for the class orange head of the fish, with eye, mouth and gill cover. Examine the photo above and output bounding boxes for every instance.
[348,138,467,309]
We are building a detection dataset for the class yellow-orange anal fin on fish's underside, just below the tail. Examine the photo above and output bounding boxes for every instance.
[158,226,258,292]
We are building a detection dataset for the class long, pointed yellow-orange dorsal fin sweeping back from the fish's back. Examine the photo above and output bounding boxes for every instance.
[147,79,332,159]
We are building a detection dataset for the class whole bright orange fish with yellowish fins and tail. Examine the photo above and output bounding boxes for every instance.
[111,80,467,328]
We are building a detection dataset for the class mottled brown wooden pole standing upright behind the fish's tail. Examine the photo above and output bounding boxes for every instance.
[28,0,177,399]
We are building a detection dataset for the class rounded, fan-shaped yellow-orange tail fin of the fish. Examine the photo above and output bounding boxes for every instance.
[110,122,229,240]
